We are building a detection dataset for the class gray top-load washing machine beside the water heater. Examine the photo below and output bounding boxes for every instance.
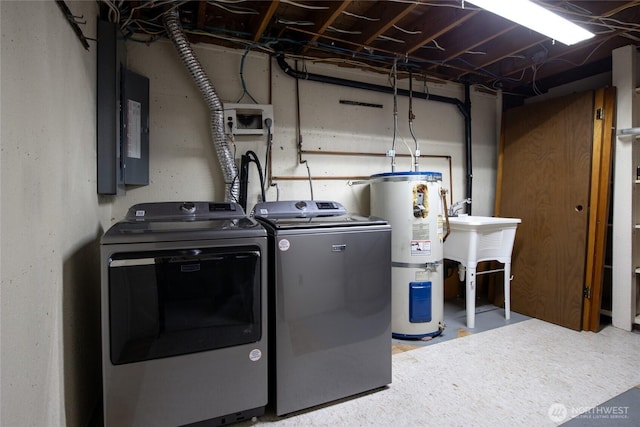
[254,201,391,415]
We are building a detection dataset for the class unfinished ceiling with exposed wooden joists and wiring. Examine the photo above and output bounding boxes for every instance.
[101,0,640,97]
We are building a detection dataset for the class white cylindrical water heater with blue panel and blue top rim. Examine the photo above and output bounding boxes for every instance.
[371,172,445,339]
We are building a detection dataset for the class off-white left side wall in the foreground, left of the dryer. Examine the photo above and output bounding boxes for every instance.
[0,1,110,426]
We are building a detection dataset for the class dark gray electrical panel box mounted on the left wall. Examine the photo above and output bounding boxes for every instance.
[97,20,149,195]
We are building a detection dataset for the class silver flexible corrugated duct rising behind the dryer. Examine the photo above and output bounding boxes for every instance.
[162,9,240,202]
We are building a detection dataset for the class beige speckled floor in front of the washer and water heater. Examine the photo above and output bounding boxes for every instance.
[248,319,640,426]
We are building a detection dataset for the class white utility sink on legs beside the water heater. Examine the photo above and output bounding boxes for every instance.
[444,215,522,328]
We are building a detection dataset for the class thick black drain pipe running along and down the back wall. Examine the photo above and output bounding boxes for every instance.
[276,53,473,214]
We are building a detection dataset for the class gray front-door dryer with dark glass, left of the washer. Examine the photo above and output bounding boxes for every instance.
[101,202,268,426]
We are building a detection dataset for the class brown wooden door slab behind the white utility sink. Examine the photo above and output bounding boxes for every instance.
[496,92,594,330]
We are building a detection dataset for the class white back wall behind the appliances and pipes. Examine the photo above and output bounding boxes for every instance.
[120,41,498,218]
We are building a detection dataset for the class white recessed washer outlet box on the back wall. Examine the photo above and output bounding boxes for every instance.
[224,104,273,136]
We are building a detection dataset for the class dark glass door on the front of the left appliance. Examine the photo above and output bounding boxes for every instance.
[109,247,261,365]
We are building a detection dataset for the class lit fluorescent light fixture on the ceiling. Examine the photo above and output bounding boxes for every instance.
[467,0,595,46]
